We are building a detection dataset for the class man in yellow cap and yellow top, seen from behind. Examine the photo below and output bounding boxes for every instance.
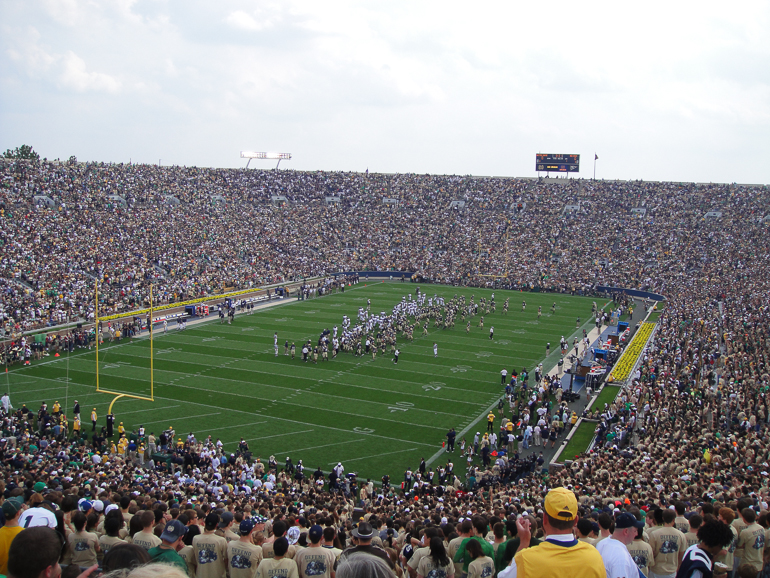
[498,488,607,578]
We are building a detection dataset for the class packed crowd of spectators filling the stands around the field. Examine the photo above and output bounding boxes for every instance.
[0,162,770,578]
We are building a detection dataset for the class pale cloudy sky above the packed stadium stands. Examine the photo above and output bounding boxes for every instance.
[0,0,770,183]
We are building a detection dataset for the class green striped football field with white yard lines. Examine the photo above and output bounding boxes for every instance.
[7,282,604,483]
